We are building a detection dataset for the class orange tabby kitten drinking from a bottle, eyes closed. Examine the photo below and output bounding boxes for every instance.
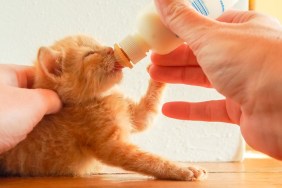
[0,36,205,180]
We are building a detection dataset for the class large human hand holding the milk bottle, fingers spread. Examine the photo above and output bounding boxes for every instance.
[149,0,282,159]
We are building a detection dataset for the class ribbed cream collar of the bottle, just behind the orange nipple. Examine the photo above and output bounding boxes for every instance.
[119,34,150,64]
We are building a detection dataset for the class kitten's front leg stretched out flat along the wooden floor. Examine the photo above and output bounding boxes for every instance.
[95,141,206,181]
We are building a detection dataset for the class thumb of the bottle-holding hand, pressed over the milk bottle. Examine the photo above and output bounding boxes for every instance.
[155,0,217,46]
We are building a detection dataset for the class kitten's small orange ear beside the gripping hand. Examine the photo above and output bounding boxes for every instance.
[37,47,63,79]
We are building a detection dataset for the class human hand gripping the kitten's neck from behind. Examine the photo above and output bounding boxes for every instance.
[0,65,61,153]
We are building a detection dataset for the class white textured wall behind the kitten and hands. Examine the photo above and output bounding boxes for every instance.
[0,0,247,161]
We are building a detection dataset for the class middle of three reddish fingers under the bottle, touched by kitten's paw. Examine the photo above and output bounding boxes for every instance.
[148,65,211,88]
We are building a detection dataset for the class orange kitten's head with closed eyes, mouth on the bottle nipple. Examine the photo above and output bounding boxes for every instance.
[34,36,122,103]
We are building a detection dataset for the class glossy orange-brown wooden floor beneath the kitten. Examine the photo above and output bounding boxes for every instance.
[0,155,282,188]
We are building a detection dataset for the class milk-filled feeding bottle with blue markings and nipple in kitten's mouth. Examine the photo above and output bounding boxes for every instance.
[115,0,238,68]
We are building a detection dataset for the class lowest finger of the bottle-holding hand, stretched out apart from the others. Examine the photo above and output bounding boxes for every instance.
[162,100,239,123]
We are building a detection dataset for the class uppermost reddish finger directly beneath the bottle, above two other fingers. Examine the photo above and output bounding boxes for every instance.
[151,44,199,66]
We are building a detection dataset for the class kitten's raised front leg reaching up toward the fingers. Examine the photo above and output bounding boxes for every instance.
[130,80,165,132]
